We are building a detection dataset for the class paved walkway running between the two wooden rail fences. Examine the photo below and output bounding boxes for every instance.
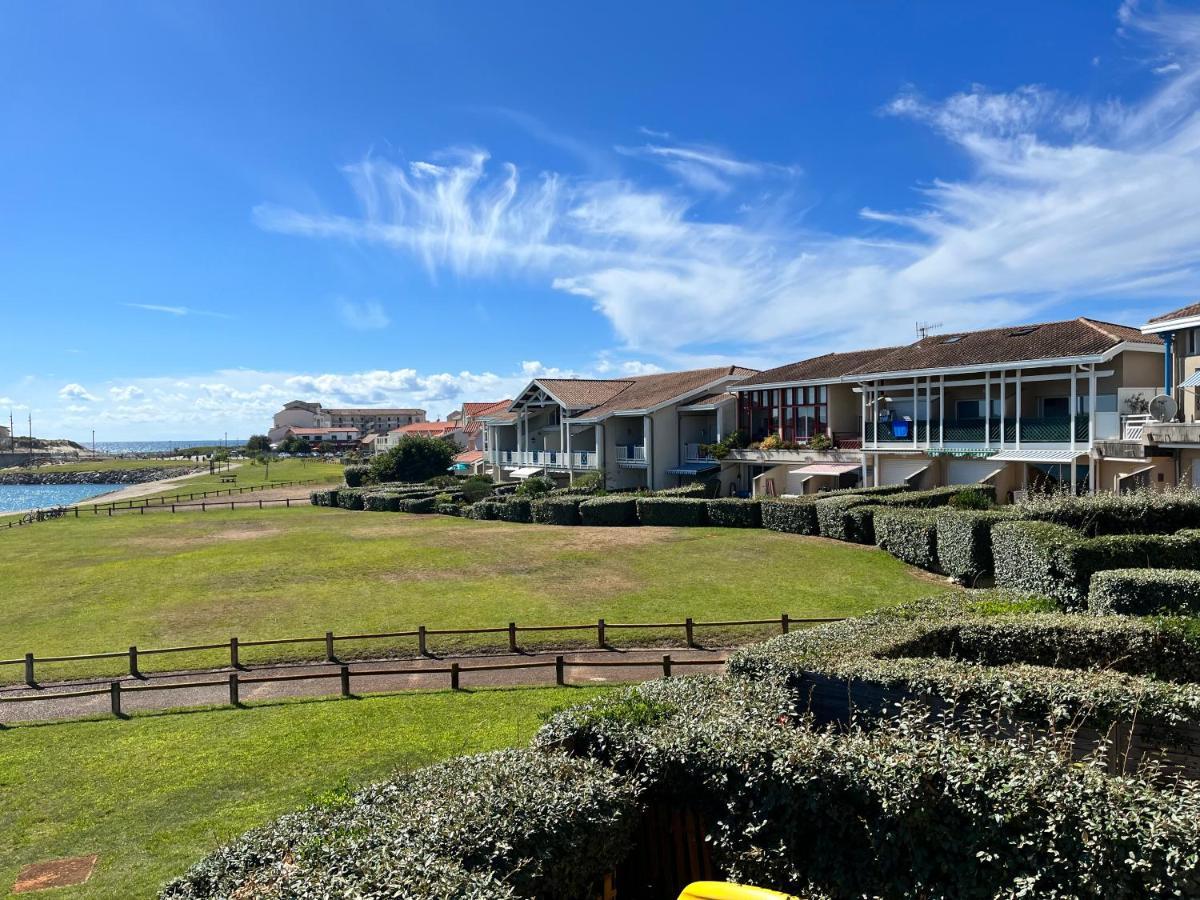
[0,647,730,722]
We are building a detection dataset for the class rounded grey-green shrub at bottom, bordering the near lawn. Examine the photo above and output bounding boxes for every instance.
[161,750,638,900]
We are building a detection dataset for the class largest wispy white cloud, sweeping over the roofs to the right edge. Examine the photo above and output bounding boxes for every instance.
[256,4,1200,359]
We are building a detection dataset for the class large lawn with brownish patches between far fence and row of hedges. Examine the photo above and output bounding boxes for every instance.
[0,508,946,680]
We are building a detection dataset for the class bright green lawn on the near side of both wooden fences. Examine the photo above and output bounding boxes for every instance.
[0,688,602,900]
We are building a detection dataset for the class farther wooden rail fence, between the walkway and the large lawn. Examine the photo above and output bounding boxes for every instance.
[0,612,841,702]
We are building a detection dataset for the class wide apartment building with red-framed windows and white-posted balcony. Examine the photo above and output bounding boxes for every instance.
[726,318,1175,499]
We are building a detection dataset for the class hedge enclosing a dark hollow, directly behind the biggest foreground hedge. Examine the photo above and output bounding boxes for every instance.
[728,595,1200,732]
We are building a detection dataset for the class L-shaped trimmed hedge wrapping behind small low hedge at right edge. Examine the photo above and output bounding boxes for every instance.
[992,522,1200,610]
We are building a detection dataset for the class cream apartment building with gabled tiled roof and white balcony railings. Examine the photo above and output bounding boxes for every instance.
[480,366,755,488]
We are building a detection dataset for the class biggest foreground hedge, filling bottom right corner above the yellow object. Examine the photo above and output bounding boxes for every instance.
[539,678,1200,900]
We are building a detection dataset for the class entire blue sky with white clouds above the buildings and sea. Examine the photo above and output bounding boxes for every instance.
[0,0,1200,440]
